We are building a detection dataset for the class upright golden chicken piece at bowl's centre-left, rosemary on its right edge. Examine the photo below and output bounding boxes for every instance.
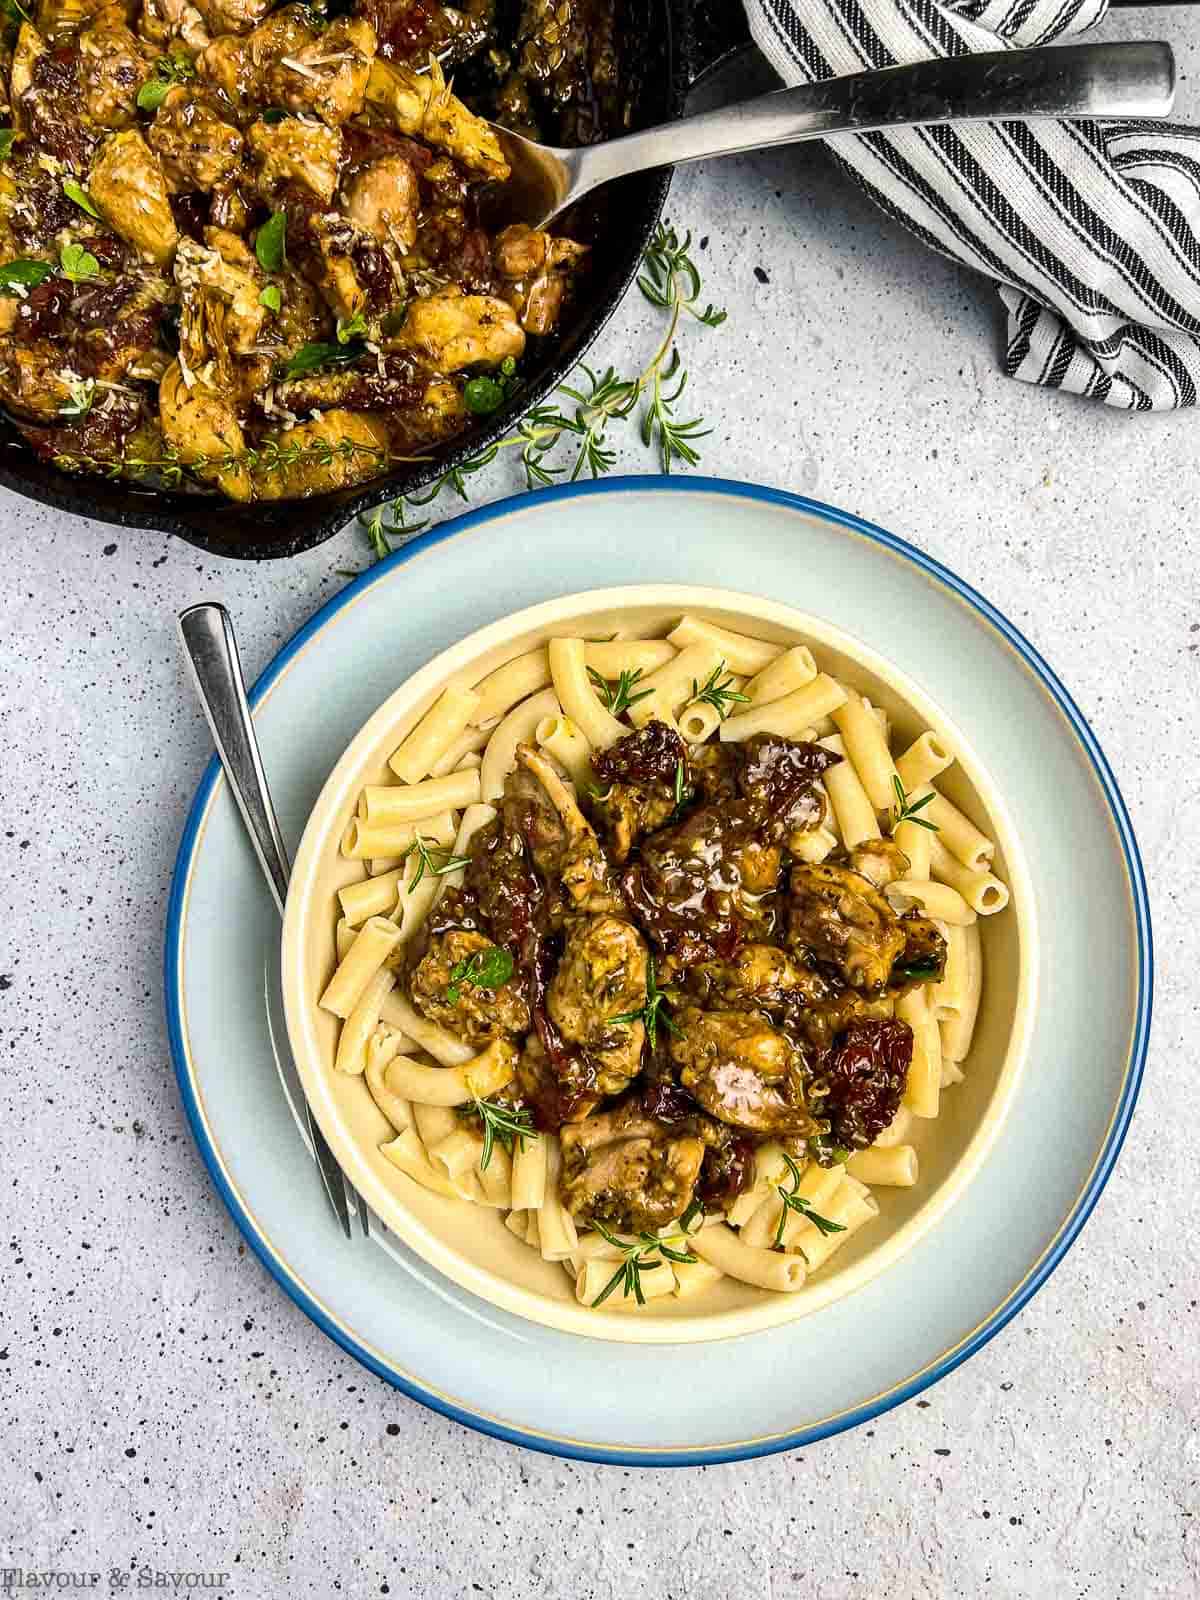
[546,915,646,1094]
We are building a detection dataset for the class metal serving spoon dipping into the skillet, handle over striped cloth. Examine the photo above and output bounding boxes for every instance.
[493,40,1174,227]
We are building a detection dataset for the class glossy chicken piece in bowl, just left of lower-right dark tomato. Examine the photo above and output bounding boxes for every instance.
[667,1005,816,1138]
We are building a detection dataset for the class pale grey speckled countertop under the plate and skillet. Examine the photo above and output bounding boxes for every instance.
[0,21,1200,1600]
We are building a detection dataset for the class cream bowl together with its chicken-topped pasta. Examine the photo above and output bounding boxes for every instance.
[283,587,1034,1342]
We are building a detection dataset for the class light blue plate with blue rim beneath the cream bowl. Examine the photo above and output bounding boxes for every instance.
[166,478,1150,1466]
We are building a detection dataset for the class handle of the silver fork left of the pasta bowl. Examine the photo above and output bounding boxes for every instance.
[179,603,291,915]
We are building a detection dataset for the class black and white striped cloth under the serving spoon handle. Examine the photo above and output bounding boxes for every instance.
[746,0,1200,411]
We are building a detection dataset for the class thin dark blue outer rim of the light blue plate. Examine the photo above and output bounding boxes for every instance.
[163,475,1154,1467]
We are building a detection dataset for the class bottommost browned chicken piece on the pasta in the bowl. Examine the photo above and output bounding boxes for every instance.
[560,1099,704,1234]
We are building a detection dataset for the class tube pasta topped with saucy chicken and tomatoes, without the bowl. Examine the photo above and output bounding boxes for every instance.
[322,616,1008,1315]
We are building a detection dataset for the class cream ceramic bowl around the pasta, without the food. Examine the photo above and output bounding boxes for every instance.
[282,584,1037,1344]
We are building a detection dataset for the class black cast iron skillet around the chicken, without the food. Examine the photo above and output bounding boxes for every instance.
[0,0,749,562]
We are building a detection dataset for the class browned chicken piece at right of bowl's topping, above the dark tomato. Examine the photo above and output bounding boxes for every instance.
[786,861,904,994]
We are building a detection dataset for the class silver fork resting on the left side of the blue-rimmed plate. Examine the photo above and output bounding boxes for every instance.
[179,603,370,1238]
